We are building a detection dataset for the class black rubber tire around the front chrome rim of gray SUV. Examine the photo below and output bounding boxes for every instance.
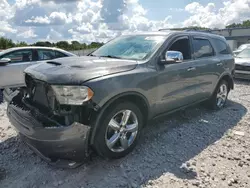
[93,102,143,159]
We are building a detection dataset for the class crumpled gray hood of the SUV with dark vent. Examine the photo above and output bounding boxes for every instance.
[24,56,137,85]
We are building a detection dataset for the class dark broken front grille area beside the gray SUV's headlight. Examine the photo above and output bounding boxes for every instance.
[25,74,56,112]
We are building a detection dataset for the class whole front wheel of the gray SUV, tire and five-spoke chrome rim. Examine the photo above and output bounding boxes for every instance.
[94,102,143,159]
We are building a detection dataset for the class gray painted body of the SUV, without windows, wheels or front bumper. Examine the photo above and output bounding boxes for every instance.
[25,32,234,117]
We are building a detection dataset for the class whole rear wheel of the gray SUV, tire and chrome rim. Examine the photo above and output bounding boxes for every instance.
[207,80,230,110]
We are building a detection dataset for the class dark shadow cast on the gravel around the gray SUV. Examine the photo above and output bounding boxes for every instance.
[0,100,247,187]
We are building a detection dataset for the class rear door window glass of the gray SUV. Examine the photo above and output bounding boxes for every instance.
[193,39,214,58]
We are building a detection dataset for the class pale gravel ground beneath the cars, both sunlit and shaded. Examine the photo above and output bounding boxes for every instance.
[0,81,250,188]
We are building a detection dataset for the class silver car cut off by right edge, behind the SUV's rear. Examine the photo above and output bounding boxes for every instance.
[234,48,250,79]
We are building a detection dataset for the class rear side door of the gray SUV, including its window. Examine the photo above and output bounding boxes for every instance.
[192,36,221,100]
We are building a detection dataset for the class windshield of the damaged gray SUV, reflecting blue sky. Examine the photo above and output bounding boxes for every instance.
[91,35,166,60]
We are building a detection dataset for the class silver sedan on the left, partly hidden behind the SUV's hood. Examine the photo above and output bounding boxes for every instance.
[0,47,76,89]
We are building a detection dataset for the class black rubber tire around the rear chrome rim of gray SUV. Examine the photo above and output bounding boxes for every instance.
[207,80,230,110]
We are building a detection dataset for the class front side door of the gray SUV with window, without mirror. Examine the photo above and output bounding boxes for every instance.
[156,36,199,114]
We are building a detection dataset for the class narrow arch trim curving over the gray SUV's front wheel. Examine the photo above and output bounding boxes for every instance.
[90,91,150,145]
